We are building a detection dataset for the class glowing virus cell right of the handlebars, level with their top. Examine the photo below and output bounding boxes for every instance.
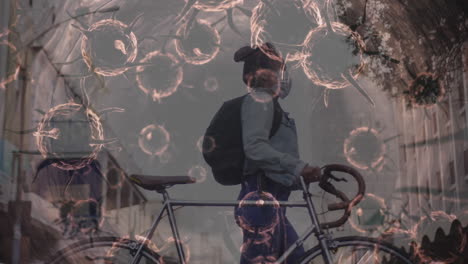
[343,127,387,171]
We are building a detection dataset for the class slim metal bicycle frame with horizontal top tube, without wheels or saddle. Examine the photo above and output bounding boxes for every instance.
[132,177,333,264]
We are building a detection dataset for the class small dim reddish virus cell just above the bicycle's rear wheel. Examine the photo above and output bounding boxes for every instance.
[69,199,102,234]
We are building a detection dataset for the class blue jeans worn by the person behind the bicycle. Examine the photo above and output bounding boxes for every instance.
[234,175,304,264]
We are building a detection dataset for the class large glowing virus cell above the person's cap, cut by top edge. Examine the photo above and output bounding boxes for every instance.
[250,0,323,60]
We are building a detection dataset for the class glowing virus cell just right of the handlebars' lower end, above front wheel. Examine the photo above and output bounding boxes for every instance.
[349,193,388,234]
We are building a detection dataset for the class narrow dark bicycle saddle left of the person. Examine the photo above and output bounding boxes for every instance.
[130,174,196,191]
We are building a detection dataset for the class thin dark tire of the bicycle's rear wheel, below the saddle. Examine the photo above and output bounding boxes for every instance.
[46,237,168,264]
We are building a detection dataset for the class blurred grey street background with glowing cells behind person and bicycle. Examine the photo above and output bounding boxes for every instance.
[0,0,468,263]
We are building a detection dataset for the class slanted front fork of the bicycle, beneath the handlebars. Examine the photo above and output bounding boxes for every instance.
[300,177,333,264]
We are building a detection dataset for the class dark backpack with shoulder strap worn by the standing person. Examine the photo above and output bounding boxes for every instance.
[202,94,282,185]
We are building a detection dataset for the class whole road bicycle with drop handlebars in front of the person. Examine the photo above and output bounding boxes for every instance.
[49,164,413,264]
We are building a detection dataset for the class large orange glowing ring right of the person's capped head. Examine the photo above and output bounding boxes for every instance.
[301,22,364,89]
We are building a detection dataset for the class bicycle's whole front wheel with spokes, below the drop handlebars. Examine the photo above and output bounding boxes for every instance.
[299,237,414,264]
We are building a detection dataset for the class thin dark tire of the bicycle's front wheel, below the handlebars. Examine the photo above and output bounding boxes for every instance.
[298,236,414,264]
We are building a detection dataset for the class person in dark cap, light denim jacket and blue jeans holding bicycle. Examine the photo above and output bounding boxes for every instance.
[234,43,320,264]
